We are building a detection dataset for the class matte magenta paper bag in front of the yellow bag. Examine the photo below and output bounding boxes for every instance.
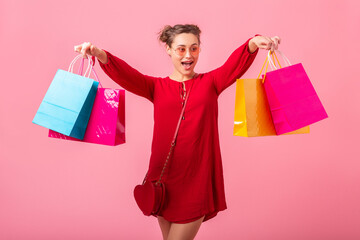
[264,51,328,135]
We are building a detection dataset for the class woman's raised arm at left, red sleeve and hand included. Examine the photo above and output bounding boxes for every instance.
[74,42,156,102]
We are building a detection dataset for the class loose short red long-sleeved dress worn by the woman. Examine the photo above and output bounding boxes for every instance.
[99,35,258,223]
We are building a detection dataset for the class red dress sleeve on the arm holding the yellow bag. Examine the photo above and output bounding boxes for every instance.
[210,34,260,95]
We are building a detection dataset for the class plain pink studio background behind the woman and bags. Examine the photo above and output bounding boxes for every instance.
[0,0,360,240]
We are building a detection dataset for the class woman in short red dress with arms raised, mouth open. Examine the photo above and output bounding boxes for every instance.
[75,24,280,240]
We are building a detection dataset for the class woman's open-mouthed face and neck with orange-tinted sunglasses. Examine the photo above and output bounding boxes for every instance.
[166,33,200,80]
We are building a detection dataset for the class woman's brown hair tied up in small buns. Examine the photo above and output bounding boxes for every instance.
[158,24,201,47]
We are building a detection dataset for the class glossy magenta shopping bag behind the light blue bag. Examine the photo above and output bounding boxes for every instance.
[48,58,125,146]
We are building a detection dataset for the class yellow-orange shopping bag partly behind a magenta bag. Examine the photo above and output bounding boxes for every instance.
[233,54,310,137]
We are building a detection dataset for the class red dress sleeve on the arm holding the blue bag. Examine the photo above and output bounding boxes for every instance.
[98,49,155,102]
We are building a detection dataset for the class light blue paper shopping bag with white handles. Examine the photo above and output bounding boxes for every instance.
[32,55,99,139]
